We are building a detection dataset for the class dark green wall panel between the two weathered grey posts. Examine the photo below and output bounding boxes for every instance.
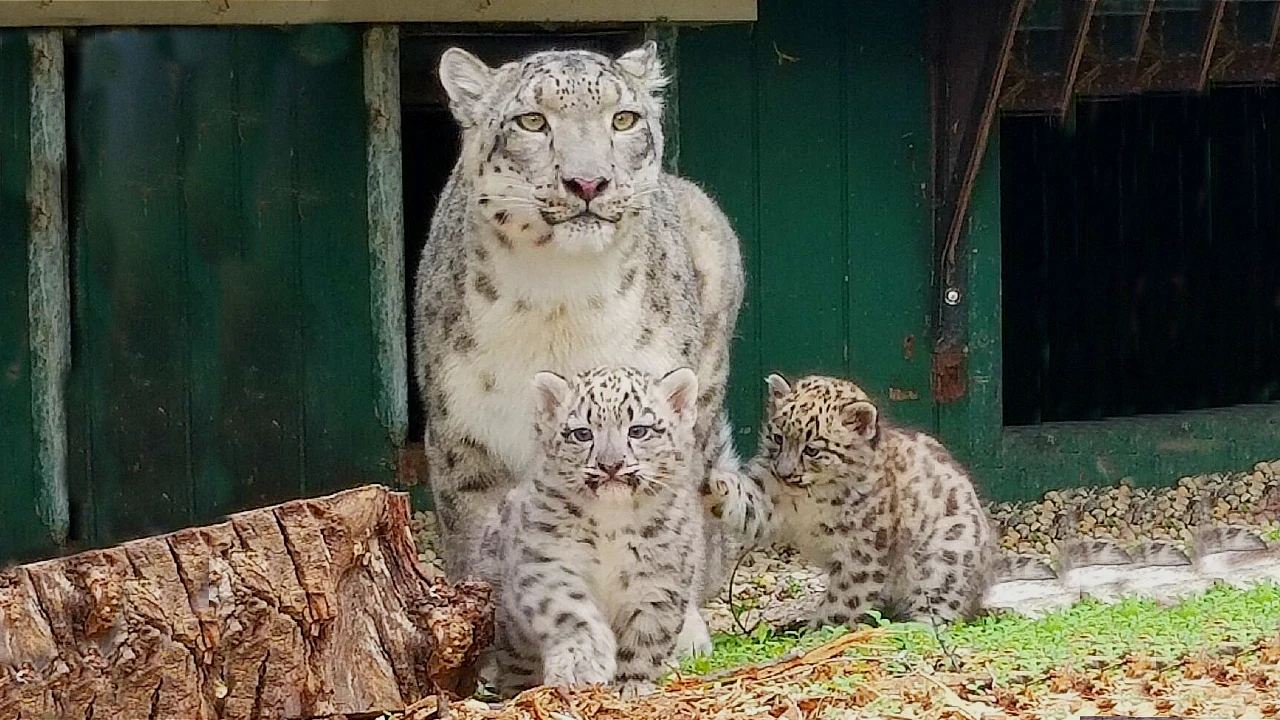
[60,26,392,543]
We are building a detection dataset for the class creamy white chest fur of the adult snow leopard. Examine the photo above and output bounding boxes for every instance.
[439,233,678,474]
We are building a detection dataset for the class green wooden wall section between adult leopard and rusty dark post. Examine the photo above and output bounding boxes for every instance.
[677,0,936,451]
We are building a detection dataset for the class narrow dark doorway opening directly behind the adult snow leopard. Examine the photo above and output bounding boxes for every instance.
[401,27,644,442]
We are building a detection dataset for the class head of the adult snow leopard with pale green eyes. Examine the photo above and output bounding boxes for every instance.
[440,41,667,254]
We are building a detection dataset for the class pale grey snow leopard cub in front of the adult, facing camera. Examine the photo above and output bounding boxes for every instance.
[474,368,710,694]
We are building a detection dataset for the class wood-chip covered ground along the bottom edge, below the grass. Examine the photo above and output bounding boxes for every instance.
[402,629,1280,720]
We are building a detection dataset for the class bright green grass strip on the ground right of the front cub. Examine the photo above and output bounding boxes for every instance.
[681,583,1280,679]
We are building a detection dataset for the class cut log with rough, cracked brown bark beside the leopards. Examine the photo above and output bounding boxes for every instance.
[0,486,493,720]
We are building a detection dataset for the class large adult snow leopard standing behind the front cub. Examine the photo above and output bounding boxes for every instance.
[415,42,742,592]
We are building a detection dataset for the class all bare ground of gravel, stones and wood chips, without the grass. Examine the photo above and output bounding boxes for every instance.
[403,461,1280,720]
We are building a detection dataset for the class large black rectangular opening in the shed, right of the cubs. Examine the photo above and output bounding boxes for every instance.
[1000,87,1280,425]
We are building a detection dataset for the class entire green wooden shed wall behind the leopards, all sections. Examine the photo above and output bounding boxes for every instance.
[0,0,1280,559]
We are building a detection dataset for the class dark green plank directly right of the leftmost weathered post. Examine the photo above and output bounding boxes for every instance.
[70,31,192,542]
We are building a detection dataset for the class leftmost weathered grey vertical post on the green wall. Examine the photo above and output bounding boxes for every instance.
[27,29,72,544]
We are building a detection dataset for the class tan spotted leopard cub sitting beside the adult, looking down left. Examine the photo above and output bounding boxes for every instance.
[710,374,997,625]
